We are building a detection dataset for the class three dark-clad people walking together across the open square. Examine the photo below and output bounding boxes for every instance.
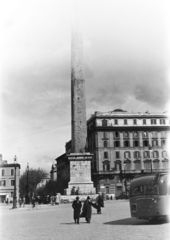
[72,194,104,224]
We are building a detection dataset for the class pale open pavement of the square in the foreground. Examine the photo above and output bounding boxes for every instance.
[0,200,170,240]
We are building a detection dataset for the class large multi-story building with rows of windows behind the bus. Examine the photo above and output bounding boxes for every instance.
[87,109,170,193]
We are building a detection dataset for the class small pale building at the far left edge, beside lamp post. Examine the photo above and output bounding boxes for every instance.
[0,154,20,202]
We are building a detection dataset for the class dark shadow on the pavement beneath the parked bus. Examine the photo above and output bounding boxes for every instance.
[104,218,169,225]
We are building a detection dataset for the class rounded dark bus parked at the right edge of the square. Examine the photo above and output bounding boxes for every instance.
[129,172,170,220]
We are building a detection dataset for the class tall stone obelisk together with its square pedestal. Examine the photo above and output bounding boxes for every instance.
[66,32,96,195]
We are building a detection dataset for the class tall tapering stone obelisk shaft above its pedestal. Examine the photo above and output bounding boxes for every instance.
[71,31,87,153]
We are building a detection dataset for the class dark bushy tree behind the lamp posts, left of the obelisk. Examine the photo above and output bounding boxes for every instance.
[19,168,48,197]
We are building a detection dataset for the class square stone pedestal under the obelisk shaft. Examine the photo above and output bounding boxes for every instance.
[66,153,96,195]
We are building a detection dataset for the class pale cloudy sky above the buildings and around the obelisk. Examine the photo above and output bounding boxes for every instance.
[0,0,170,173]
